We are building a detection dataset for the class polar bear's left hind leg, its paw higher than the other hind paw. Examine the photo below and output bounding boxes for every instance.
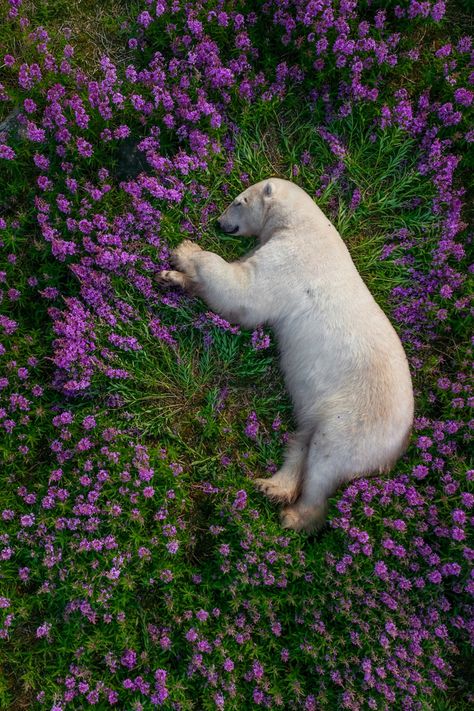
[254,432,310,504]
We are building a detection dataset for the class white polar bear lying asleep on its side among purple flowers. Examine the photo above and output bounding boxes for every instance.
[161,178,413,531]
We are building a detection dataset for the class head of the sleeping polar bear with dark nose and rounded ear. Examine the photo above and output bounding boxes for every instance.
[217,179,277,237]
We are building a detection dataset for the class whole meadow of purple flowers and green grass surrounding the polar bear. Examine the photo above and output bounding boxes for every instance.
[0,0,474,711]
